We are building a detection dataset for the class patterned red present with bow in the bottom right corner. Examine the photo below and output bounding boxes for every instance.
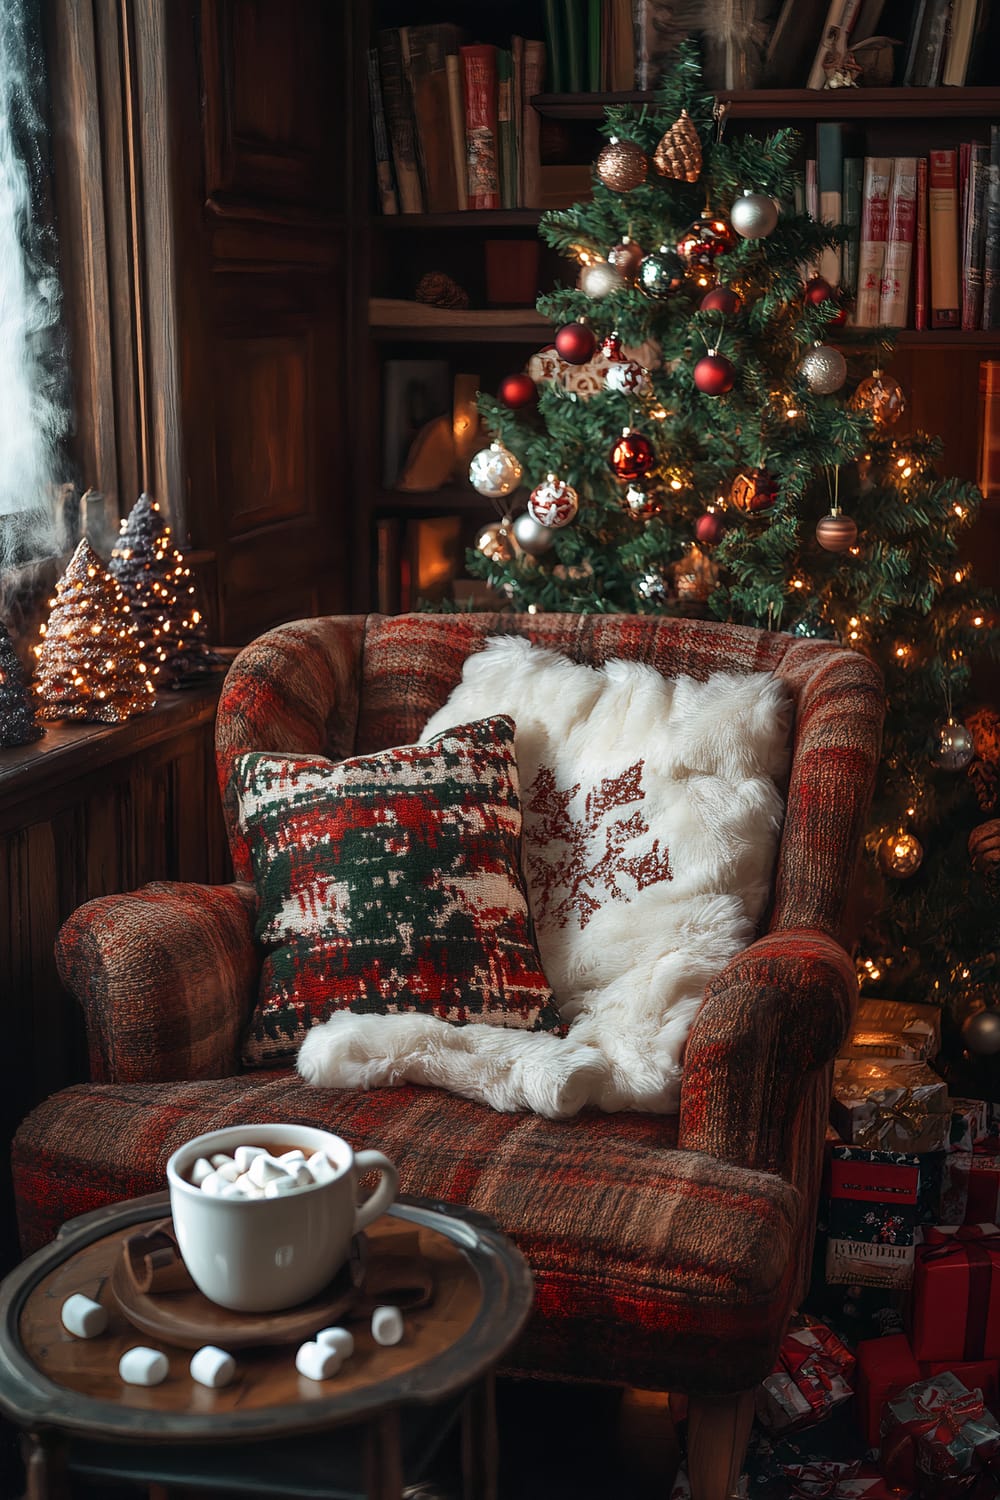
[879,1373,1000,1500]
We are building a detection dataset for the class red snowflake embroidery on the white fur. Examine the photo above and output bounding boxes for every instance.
[526,761,673,927]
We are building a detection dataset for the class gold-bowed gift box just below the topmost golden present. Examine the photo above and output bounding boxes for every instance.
[831,1058,952,1152]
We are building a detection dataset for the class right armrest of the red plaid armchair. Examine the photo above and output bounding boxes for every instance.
[679,927,858,1197]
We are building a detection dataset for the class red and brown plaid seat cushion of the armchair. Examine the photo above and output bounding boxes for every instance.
[13,1071,802,1395]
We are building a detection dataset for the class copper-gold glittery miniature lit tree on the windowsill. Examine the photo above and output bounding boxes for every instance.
[34,537,153,725]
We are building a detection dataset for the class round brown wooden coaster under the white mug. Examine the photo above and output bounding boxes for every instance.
[111,1235,369,1350]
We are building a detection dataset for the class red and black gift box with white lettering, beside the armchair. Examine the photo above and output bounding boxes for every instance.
[826,1143,921,1287]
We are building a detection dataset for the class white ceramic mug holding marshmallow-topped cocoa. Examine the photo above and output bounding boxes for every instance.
[166,1125,399,1313]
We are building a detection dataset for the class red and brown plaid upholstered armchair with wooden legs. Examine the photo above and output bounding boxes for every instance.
[13,615,883,1500]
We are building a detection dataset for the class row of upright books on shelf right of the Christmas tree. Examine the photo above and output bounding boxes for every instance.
[805,122,1000,330]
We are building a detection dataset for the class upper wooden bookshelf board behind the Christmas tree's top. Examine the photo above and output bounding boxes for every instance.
[531,89,1000,123]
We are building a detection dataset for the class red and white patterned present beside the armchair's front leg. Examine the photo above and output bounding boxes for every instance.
[756,1323,855,1433]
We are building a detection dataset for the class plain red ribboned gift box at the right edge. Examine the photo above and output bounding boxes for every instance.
[907,1224,1000,1361]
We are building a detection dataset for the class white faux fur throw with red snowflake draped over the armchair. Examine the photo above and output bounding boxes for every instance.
[298,636,792,1119]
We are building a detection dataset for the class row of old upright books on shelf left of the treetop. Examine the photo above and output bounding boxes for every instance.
[369,24,546,213]
